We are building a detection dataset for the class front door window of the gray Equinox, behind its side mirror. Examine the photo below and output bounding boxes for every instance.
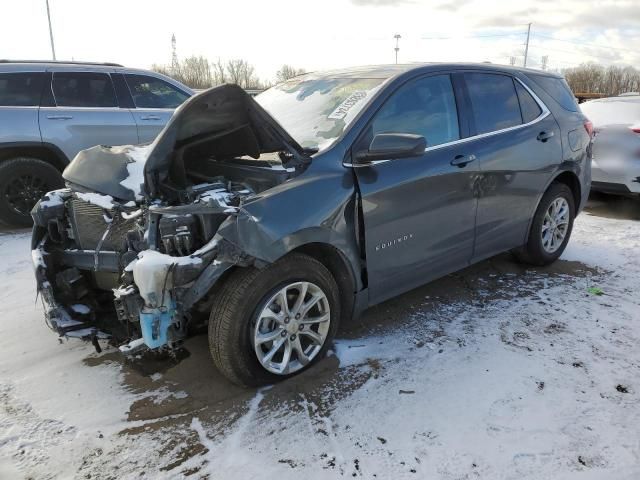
[372,75,460,146]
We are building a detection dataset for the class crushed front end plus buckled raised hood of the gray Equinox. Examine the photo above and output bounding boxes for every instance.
[32,86,304,353]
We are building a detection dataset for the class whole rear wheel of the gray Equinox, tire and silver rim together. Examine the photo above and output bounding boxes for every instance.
[515,183,576,265]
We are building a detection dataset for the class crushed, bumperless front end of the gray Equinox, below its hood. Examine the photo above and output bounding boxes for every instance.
[32,181,252,353]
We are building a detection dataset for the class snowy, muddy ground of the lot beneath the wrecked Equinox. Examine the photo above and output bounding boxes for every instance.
[0,208,640,480]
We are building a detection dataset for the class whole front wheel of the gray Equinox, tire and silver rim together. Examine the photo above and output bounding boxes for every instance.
[209,253,340,386]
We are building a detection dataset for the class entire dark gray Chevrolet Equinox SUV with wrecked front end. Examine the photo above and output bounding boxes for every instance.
[32,64,591,385]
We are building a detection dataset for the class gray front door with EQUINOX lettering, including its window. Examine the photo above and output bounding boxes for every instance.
[354,74,478,304]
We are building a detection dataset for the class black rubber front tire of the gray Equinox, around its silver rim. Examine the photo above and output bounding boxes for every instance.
[209,253,340,387]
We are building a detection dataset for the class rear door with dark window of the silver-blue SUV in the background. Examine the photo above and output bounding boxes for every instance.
[39,70,138,160]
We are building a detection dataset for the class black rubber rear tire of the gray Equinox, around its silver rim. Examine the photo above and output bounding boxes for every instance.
[515,183,576,266]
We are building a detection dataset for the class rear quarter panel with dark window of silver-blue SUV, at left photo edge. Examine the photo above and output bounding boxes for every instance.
[0,72,46,144]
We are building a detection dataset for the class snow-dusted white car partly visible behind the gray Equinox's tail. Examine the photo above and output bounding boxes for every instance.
[580,93,640,196]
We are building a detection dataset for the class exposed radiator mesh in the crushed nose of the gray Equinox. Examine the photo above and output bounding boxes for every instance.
[71,197,136,252]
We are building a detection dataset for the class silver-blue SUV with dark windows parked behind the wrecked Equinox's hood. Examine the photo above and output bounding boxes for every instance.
[0,60,193,226]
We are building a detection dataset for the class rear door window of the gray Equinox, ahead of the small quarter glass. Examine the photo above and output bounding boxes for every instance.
[464,73,522,134]
